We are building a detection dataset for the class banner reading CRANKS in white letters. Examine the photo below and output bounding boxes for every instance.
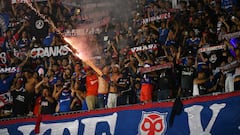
[31,45,68,58]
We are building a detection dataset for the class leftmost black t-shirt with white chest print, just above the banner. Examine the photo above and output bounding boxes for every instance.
[11,87,31,115]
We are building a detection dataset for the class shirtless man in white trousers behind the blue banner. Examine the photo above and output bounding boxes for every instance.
[107,64,122,108]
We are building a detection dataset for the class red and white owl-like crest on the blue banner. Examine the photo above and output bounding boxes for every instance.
[138,111,167,135]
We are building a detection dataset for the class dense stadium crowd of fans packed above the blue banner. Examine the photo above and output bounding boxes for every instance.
[0,0,240,117]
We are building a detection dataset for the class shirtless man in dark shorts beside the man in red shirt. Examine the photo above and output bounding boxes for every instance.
[98,66,110,108]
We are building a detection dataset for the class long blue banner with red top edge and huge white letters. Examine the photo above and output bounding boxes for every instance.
[0,92,240,135]
